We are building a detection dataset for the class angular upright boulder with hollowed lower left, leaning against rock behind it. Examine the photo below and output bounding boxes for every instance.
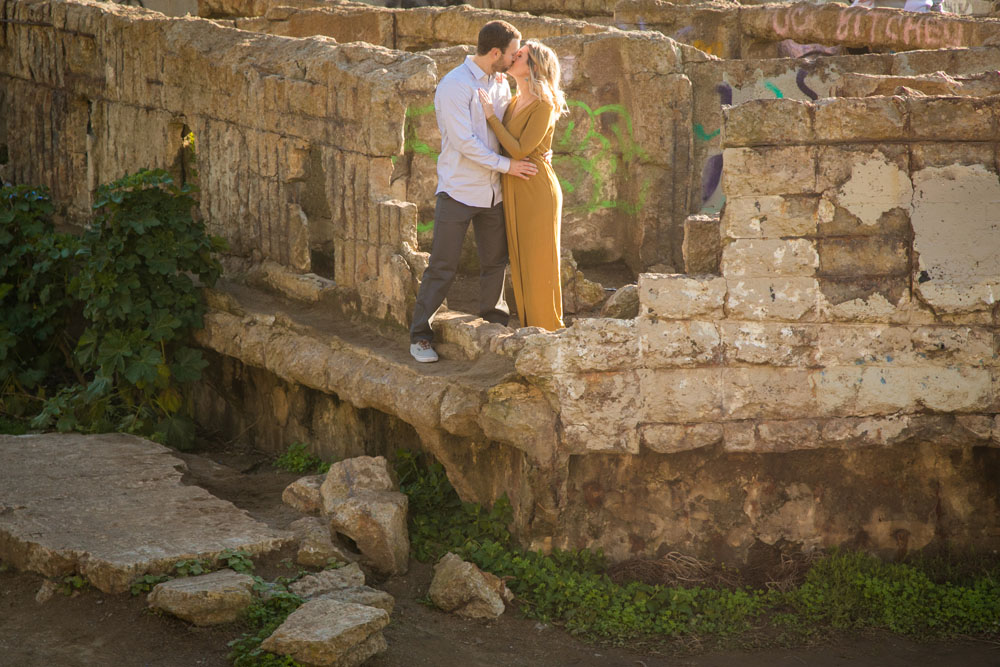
[329,491,410,575]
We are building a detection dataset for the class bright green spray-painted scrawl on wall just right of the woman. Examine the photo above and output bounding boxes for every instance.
[552,100,649,215]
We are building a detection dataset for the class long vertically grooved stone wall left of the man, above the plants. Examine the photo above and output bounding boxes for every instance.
[0,0,436,322]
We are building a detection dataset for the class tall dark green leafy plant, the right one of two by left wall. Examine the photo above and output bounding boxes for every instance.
[34,169,226,446]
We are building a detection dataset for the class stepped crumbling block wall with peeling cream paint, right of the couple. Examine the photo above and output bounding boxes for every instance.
[496,97,1000,557]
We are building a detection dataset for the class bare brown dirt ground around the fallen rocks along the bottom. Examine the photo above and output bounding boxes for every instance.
[0,448,1000,667]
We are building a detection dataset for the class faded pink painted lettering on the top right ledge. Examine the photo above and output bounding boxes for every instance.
[771,5,975,49]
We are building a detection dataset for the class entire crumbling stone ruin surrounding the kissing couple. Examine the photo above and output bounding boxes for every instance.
[0,0,1000,562]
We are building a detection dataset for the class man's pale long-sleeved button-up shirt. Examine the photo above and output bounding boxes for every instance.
[434,56,511,207]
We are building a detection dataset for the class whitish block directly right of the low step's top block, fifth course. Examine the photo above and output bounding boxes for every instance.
[726,277,819,321]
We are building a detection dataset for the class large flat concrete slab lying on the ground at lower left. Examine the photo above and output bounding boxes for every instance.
[0,433,293,593]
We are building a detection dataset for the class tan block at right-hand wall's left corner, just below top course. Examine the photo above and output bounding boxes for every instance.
[722,146,818,198]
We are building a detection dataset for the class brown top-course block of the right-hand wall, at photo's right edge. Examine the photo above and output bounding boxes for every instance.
[907,97,1000,141]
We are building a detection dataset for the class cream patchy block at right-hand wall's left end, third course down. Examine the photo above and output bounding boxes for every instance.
[722,195,832,239]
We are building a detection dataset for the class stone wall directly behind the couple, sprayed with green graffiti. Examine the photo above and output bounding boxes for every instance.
[227,3,705,273]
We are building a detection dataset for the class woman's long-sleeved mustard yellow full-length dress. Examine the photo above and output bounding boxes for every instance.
[488,96,565,331]
